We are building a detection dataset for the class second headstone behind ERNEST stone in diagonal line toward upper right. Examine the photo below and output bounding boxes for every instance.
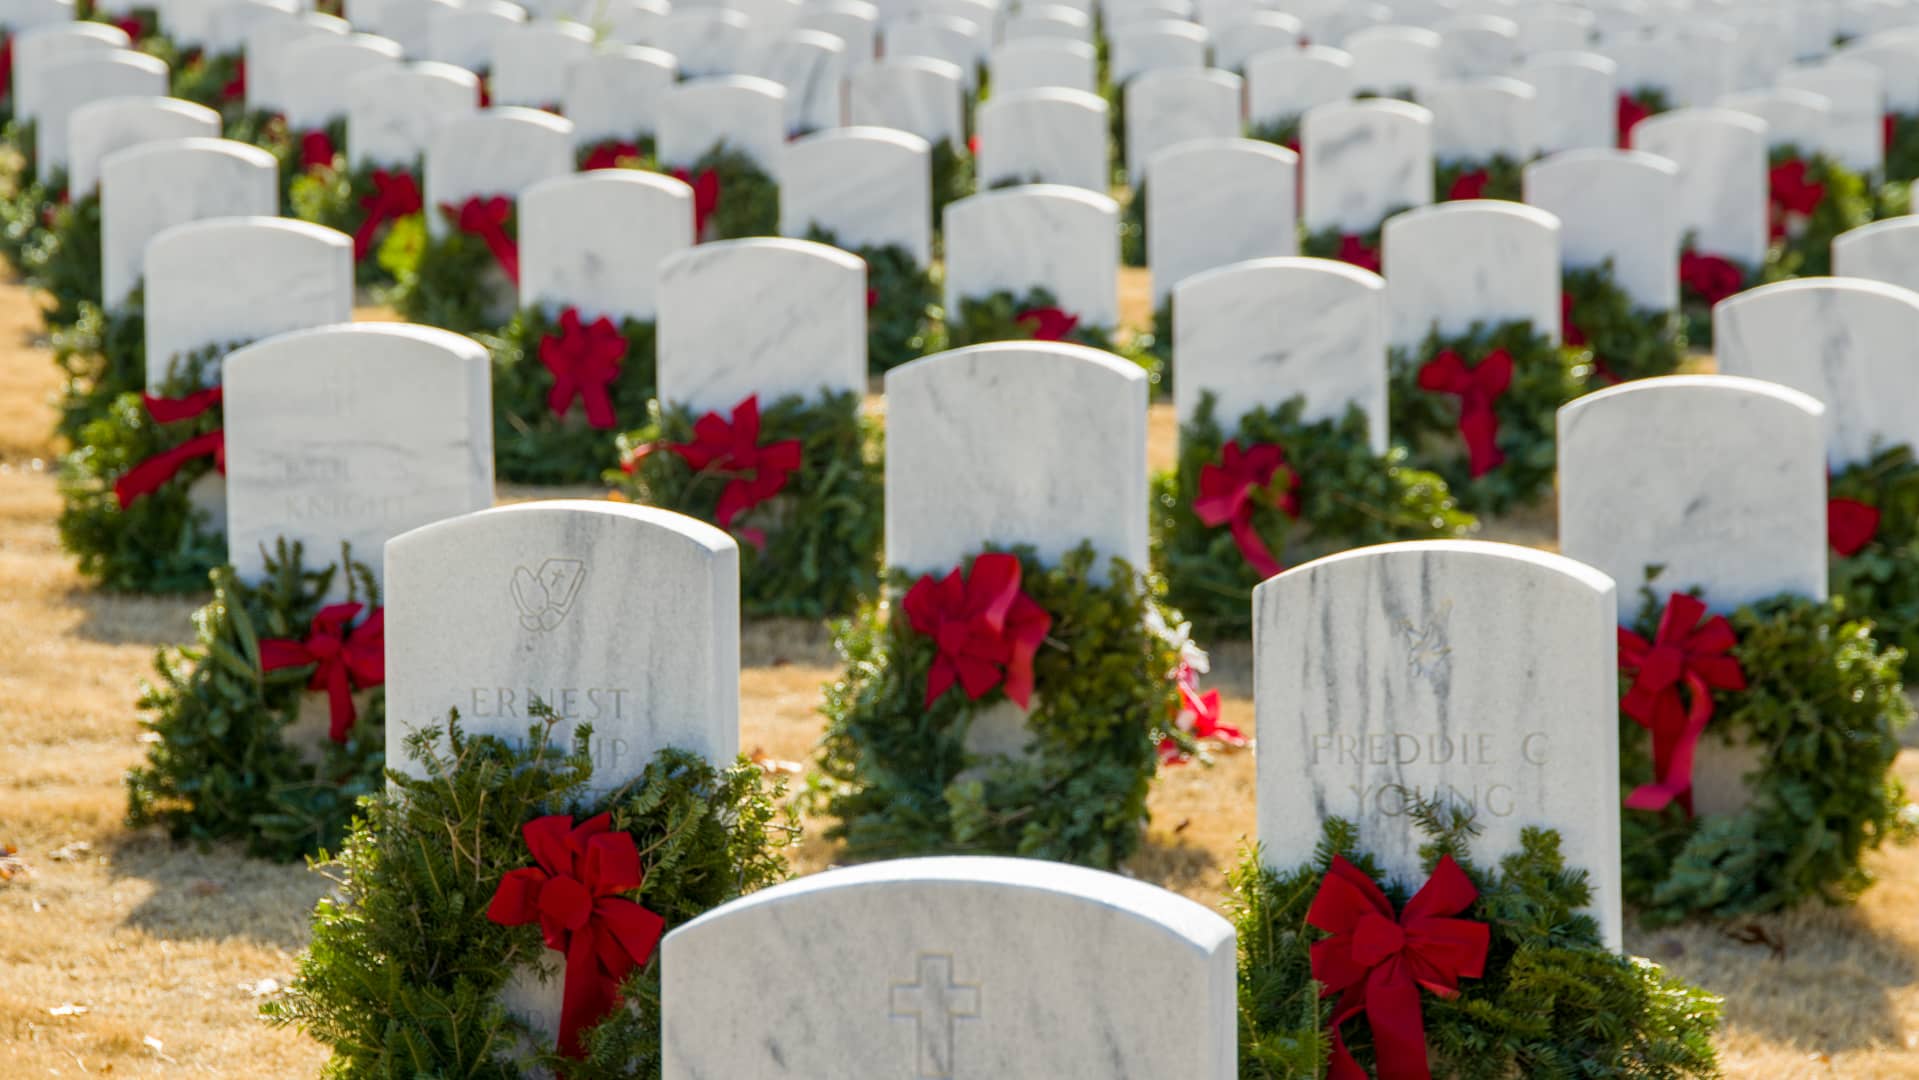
[1173,259,1387,455]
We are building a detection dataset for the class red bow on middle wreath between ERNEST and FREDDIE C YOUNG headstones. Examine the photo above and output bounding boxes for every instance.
[904,552,1054,708]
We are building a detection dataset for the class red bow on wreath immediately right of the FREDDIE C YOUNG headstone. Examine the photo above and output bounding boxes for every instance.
[1620,593,1746,813]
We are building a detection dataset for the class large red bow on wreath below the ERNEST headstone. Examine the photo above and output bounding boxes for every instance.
[486,813,666,1059]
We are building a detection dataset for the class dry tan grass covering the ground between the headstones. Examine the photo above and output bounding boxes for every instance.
[0,268,1919,1080]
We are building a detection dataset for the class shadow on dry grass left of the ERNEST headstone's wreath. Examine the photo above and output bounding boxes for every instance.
[107,829,332,951]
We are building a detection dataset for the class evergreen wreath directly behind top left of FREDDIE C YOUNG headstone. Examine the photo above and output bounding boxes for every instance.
[1153,391,1478,637]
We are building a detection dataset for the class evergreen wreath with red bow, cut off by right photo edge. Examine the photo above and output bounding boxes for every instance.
[1827,443,1919,656]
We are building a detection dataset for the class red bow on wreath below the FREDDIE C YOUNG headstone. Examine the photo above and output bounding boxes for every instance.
[1307,856,1493,1080]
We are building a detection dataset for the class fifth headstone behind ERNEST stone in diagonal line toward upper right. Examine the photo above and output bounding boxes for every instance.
[1633,109,1769,267]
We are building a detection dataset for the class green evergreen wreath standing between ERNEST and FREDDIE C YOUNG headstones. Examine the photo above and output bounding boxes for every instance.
[816,545,1192,867]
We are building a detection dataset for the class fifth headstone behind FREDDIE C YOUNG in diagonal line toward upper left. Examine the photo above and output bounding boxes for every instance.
[345,61,480,169]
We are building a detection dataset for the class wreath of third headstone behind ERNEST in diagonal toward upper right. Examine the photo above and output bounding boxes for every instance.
[1391,320,1587,514]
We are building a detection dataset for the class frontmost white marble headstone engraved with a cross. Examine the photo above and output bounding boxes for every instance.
[660,856,1238,1080]
